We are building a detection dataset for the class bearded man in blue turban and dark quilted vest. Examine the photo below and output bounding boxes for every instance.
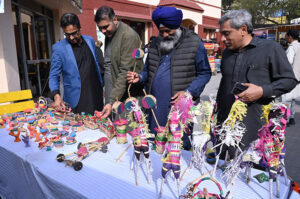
[127,6,211,146]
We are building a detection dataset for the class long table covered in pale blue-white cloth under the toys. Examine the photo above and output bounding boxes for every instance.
[0,129,289,199]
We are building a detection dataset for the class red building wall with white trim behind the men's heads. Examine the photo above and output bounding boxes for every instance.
[79,0,221,44]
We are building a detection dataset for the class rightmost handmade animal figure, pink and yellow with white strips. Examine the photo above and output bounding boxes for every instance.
[224,103,290,199]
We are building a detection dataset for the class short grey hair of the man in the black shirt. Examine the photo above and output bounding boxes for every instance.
[219,10,253,33]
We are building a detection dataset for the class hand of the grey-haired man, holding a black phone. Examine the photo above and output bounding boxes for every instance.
[237,83,263,103]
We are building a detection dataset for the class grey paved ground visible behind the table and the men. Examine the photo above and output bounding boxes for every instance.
[201,73,300,183]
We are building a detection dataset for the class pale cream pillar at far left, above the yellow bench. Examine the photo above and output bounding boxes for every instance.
[0,0,21,93]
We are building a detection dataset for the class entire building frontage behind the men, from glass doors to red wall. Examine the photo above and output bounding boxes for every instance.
[0,0,221,97]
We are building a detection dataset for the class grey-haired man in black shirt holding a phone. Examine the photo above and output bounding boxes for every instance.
[217,10,297,153]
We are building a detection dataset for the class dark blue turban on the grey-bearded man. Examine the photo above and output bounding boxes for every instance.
[152,6,182,29]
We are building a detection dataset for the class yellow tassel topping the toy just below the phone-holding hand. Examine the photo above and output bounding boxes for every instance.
[225,100,247,127]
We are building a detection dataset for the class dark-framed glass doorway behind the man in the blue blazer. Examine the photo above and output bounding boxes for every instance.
[12,3,55,98]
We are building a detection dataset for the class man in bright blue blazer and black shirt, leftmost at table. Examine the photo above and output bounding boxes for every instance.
[49,13,103,114]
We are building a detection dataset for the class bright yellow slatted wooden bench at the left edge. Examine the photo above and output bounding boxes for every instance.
[0,90,34,115]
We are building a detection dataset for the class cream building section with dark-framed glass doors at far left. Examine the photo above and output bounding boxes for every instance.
[0,0,81,97]
